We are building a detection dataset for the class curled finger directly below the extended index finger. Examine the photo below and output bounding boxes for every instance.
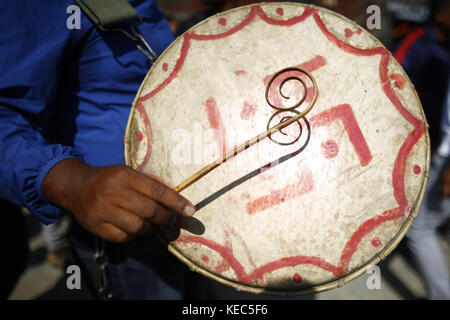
[120,191,170,224]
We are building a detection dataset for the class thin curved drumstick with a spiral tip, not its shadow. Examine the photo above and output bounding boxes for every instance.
[174,67,318,192]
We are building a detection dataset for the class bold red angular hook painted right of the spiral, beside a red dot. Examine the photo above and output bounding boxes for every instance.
[310,104,372,167]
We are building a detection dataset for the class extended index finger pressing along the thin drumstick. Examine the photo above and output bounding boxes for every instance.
[129,174,195,217]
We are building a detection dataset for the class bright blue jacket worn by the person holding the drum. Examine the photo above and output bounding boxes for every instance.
[0,0,173,223]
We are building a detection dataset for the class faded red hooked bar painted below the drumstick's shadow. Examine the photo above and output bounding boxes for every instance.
[246,168,314,214]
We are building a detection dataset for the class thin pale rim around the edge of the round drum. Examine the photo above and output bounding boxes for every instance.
[123,2,431,296]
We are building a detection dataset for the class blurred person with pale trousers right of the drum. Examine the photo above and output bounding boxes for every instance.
[394,0,450,299]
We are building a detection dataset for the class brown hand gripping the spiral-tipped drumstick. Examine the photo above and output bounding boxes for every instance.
[42,159,195,242]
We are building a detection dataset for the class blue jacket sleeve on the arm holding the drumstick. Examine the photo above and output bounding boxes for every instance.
[0,0,82,223]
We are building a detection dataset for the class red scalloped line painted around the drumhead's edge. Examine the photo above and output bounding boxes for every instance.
[138,6,425,283]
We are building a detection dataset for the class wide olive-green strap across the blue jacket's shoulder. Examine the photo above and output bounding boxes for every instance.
[75,0,142,30]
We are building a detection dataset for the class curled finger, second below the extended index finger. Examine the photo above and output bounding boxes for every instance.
[104,208,150,235]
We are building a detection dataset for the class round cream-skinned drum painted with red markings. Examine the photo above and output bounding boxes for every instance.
[124,2,430,295]
